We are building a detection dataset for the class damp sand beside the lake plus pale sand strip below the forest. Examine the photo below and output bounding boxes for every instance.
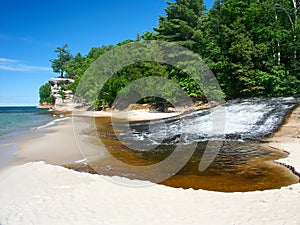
[0,110,188,172]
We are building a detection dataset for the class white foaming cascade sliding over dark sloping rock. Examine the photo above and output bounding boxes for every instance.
[118,97,300,147]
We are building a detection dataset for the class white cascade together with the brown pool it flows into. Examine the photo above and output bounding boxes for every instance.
[68,98,300,192]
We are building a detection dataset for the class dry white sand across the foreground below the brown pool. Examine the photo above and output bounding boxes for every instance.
[0,163,300,225]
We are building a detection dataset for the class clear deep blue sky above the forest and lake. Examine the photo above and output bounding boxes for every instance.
[0,0,213,106]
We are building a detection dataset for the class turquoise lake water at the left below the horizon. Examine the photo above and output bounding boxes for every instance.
[0,107,55,144]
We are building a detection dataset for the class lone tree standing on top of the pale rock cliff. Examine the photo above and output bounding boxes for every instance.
[50,44,72,78]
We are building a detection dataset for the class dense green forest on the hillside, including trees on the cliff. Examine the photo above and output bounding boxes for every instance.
[40,0,300,109]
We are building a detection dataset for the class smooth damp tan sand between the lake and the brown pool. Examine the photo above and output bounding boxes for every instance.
[0,117,79,172]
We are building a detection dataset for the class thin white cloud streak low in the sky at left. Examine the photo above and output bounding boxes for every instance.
[0,58,51,72]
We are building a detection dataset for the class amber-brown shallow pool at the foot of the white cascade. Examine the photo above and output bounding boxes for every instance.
[67,118,299,192]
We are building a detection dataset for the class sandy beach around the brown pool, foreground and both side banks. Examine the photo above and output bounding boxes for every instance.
[0,107,300,225]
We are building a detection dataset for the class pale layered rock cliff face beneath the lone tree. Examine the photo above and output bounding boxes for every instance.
[49,78,74,111]
